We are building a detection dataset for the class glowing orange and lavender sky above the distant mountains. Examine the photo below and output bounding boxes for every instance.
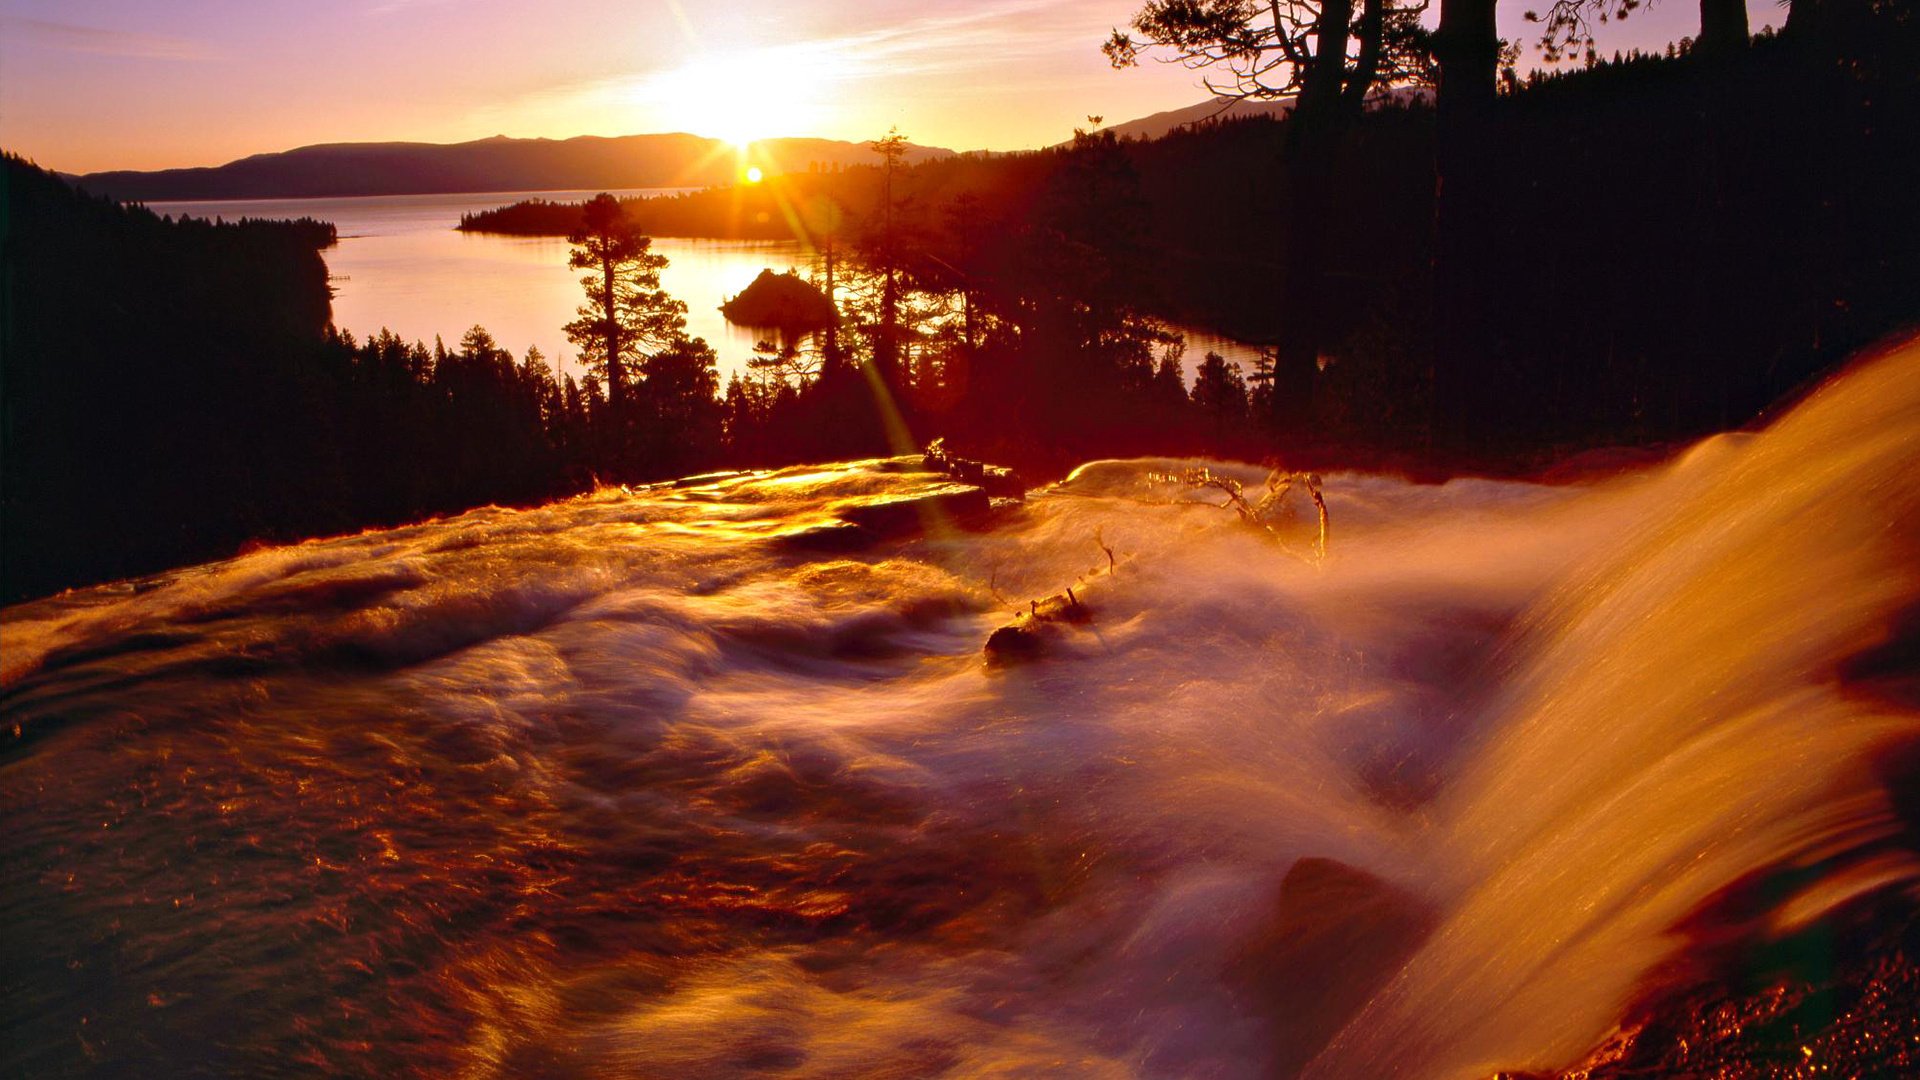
[0,0,1784,173]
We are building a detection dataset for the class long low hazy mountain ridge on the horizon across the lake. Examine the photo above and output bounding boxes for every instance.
[67,133,952,202]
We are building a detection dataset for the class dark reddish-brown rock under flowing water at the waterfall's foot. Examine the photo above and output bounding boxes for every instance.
[1229,857,1434,1076]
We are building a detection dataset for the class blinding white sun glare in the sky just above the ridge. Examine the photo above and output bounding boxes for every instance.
[639,50,828,150]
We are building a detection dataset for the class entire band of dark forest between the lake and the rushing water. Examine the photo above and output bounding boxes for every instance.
[4,10,1920,598]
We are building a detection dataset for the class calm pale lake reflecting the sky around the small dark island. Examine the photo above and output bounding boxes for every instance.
[148,188,1256,382]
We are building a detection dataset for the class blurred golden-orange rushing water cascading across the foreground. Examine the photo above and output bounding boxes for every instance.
[11,338,1920,1078]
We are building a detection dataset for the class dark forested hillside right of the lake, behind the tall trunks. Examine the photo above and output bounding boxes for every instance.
[461,17,1920,453]
